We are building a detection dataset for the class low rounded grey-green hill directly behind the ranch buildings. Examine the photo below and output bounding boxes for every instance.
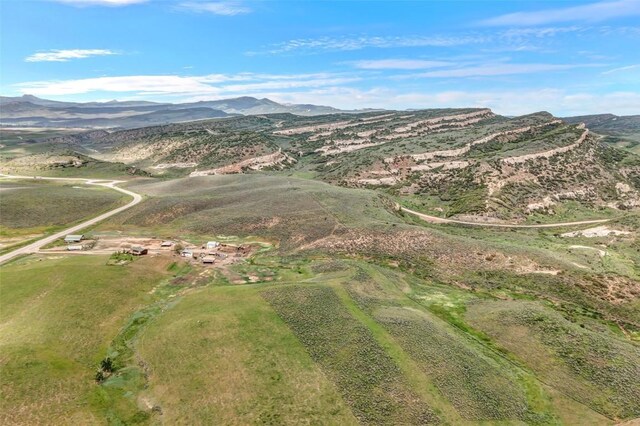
[100,175,401,251]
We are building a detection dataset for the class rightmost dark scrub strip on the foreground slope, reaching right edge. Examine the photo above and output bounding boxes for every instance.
[467,301,640,418]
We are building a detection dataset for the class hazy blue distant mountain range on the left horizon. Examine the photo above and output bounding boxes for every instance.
[0,95,340,129]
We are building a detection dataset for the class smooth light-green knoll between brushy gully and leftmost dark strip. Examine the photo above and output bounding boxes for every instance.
[137,286,357,425]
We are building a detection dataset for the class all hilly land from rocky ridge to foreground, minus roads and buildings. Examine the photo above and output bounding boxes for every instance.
[0,105,640,425]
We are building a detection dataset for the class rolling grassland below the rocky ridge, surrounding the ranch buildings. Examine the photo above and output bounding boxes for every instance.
[0,175,640,425]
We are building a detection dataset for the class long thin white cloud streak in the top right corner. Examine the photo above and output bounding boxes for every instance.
[480,0,640,26]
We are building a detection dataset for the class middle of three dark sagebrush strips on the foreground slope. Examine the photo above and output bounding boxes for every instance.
[345,269,543,422]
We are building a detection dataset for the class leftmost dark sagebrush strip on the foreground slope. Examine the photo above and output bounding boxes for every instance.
[262,286,437,424]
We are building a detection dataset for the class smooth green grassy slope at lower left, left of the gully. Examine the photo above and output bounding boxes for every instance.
[0,256,172,424]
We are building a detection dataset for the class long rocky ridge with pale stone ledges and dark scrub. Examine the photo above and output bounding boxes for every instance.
[10,108,640,221]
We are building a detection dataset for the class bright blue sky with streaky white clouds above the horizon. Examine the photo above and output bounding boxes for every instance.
[0,0,640,115]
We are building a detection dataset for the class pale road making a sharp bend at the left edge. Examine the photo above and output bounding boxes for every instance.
[0,174,142,263]
